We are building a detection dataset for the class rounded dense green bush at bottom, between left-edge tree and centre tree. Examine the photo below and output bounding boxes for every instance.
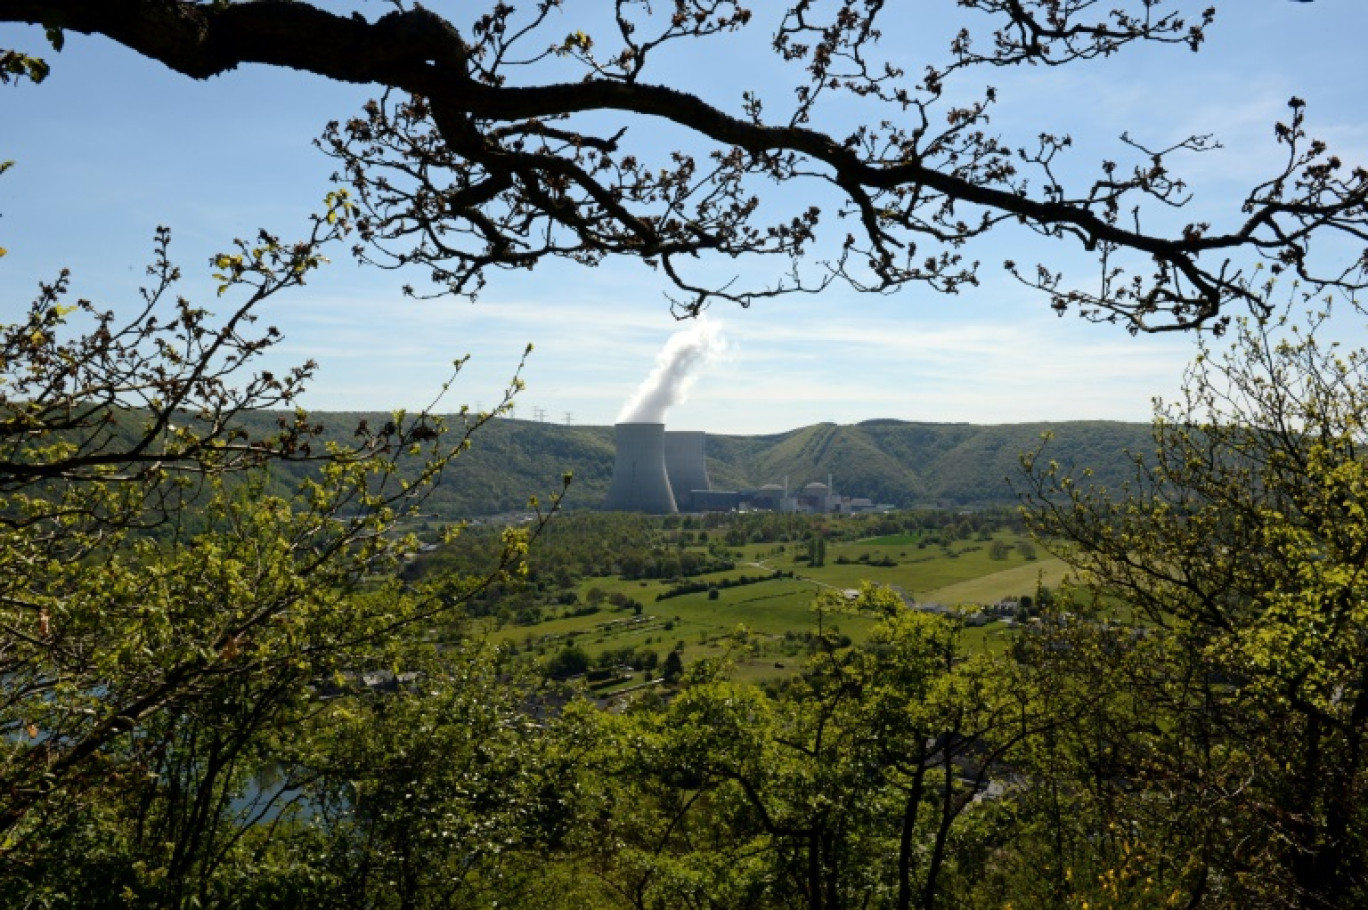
[274,643,573,910]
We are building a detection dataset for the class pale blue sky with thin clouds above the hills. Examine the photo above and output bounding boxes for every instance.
[0,0,1368,434]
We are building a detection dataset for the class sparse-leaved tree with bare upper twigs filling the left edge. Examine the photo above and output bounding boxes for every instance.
[0,213,554,906]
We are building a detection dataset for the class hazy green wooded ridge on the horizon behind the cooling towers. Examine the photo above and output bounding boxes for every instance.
[254,413,1153,520]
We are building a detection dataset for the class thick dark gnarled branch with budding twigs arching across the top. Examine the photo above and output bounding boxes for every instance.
[0,0,1368,331]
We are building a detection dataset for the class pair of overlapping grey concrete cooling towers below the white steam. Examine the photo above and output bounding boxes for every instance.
[603,423,710,515]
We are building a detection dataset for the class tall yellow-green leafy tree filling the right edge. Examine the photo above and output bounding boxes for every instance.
[1030,306,1368,907]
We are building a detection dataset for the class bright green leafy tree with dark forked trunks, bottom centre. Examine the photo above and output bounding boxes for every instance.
[569,588,1022,910]
